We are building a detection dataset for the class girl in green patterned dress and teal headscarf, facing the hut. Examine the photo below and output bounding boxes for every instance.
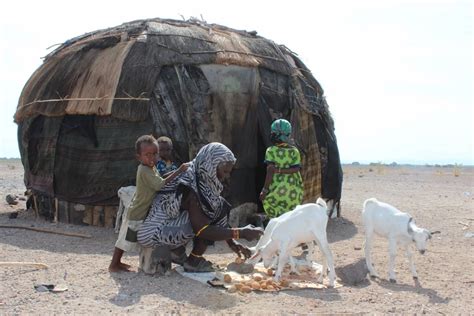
[260,119,303,218]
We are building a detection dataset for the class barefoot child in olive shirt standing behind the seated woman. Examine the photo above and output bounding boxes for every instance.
[109,135,188,272]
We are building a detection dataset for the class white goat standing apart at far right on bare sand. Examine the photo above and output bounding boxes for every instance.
[362,198,439,283]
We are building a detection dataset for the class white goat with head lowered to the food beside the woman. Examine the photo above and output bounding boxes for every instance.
[249,198,336,287]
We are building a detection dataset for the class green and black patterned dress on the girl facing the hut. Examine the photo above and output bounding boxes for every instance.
[263,145,303,218]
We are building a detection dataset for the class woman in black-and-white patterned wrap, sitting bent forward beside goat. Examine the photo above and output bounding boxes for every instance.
[138,143,263,272]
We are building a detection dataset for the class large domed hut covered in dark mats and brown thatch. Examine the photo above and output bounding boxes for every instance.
[15,19,342,225]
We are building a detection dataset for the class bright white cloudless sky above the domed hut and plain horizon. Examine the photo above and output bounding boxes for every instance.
[0,0,474,165]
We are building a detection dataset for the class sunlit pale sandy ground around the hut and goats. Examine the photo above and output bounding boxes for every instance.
[0,160,474,315]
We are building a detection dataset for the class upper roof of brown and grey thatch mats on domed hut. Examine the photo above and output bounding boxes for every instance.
[15,18,325,122]
